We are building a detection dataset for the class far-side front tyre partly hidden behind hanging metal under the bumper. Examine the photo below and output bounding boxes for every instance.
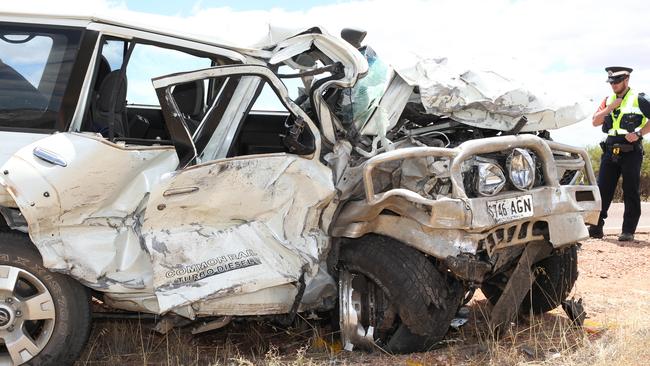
[481,245,578,314]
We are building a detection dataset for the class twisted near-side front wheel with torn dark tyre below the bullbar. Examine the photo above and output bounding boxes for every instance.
[339,235,464,353]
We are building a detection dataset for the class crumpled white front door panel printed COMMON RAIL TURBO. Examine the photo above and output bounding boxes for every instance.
[142,154,335,311]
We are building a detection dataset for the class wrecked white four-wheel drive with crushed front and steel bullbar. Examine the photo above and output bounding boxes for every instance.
[0,15,600,364]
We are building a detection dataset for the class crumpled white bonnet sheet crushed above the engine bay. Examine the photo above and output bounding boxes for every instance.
[397,59,586,132]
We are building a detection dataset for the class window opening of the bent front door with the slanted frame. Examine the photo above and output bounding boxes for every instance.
[177,75,314,163]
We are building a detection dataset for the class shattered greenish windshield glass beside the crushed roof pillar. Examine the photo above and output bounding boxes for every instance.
[337,46,391,131]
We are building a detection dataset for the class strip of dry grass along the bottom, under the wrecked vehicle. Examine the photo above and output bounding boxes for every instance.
[77,300,650,366]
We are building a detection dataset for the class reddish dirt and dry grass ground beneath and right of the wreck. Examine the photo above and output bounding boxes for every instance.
[78,234,650,366]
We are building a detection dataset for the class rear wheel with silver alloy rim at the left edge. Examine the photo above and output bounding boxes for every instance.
[0,233,91,365]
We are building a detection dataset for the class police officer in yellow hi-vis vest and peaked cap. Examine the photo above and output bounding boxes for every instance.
[589,66,650,241]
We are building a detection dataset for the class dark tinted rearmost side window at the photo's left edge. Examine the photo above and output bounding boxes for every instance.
[0,25,81,129]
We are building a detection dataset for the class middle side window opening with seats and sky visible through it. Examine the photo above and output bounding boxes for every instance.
[82,37,215,140]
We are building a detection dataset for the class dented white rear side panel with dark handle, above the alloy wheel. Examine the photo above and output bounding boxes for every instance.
[2,133,178,292]
